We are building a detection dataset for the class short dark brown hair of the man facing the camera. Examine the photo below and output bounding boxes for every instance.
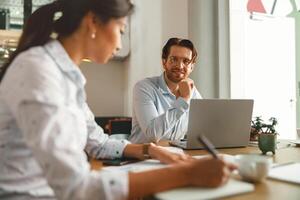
[161,38,198,63]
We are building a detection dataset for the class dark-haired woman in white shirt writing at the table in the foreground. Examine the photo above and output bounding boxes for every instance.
[0,0,235,200]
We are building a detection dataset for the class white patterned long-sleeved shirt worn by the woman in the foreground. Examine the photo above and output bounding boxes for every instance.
[0,40,128,200]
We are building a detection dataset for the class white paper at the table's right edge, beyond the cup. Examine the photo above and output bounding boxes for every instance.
[268,163,300,184]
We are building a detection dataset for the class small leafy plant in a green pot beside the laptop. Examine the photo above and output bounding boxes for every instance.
[251,117,278,154]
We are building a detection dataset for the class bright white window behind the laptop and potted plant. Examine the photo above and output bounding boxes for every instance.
[230,0,296,138]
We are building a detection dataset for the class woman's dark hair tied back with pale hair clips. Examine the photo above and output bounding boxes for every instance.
[0,0,133,81]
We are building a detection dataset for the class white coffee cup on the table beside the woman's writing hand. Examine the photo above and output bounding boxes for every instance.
[235,154,272,182]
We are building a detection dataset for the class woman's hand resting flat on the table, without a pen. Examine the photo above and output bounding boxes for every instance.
[148,143,194,164]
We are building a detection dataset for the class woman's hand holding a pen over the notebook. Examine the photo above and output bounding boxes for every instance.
[185,157,237,187]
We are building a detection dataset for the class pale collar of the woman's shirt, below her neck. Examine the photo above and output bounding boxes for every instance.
[44,40,86,88]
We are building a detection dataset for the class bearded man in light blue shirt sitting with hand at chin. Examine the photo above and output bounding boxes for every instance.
[129,38,201,143]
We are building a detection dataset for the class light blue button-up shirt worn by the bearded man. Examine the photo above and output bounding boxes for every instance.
[129,74,201,143]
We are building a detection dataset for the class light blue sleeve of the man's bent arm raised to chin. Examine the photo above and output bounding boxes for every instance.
[133,82,189,142]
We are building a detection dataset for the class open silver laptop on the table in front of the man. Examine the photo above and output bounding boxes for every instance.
[170,99,253,149]
